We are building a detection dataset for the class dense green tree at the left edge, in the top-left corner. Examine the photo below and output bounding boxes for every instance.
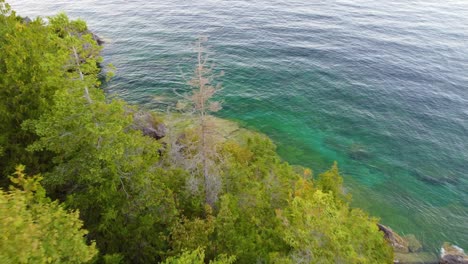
[0,5,68,179]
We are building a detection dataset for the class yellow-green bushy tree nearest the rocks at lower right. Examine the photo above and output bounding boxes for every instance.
[277,180,393,263]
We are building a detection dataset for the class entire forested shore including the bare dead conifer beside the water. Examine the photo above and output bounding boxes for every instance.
[0,0,393,263]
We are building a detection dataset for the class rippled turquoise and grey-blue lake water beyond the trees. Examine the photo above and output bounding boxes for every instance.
[10,0,468,251]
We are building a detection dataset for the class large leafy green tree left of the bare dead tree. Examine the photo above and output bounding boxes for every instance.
[27,61,177,263]
